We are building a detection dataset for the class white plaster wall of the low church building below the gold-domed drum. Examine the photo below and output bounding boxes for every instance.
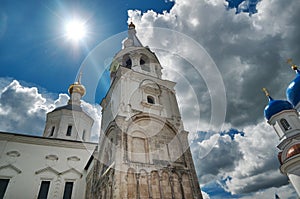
[0,133,96,199]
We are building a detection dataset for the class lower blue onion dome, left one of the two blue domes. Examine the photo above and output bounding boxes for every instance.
[265,97,293,120]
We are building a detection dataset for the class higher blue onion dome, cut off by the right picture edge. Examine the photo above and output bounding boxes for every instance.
[286,69,300,106]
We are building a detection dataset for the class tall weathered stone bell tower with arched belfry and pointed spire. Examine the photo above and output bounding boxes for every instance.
[93,23,202,199]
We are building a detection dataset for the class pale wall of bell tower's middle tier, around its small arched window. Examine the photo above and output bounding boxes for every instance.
[101,67,180,130]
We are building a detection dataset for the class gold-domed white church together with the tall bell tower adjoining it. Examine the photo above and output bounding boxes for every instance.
[0,23,202,199]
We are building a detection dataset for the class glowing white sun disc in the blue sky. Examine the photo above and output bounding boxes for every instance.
[65,19,86,41]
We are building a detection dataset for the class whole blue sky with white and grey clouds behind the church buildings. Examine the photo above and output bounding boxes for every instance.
[0,0,300,198]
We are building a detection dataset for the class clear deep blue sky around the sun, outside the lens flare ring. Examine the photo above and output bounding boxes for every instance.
[0,0,174,101]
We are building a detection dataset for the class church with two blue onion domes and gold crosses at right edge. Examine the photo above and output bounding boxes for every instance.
[263,60,300,196]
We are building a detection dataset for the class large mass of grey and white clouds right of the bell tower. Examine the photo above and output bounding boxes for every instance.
[129,0,300,198]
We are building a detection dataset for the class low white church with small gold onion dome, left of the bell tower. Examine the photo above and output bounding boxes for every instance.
[0,79,97,199]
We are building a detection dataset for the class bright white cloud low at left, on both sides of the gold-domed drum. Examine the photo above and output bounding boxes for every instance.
[0,78,101,142]
